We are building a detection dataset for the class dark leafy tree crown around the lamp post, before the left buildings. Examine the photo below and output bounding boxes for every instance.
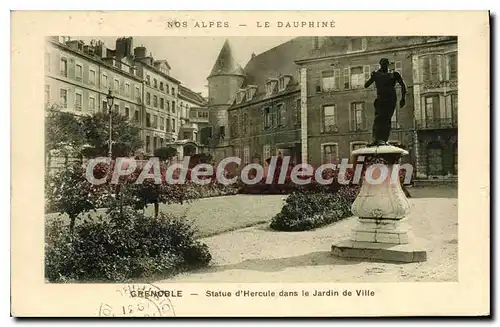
[82,112,143,157]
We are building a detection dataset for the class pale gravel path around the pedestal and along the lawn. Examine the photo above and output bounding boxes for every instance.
[158,198,458,283]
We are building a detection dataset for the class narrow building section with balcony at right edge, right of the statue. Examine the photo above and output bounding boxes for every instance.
[412,37,458,179]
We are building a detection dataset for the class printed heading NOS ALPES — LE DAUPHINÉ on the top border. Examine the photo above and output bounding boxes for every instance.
[166,20,335,29]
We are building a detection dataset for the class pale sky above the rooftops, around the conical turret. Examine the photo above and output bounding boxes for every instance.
[77,36,292,96]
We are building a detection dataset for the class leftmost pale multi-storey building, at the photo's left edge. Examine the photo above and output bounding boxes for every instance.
[44,37,142,124]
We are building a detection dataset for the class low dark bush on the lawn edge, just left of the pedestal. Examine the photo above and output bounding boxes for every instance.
[270,186,359,231]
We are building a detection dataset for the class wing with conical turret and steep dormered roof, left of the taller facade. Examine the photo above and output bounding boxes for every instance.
[208,37,308,164]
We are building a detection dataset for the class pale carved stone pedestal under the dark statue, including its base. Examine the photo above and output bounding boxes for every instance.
[332,145,427,262]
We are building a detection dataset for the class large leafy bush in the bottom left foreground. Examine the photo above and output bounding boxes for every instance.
[45,208,212,282]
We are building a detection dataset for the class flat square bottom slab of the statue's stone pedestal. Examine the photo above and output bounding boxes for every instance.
[332,240,427,262]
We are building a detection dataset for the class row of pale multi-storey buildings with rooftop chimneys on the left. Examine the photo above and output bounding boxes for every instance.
[44,37,203,155]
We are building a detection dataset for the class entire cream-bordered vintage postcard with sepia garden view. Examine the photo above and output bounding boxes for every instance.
[11,11,490,317]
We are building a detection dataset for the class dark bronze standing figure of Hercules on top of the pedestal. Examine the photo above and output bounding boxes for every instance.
[365,58,406,146]
